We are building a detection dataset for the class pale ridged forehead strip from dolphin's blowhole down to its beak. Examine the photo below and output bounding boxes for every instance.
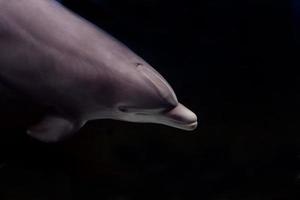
[137,63,178,108]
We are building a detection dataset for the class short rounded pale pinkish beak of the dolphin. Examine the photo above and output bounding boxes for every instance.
[164,103,198,131]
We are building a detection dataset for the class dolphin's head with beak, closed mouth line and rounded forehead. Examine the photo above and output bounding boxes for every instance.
[105,64,197,130]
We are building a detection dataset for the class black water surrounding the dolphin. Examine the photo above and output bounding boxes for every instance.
[0,0,300,200]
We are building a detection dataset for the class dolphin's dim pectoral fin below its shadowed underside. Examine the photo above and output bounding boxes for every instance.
[27,115,84,143]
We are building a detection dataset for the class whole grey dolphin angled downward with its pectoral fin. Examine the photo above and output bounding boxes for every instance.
[0,0,197,142]
